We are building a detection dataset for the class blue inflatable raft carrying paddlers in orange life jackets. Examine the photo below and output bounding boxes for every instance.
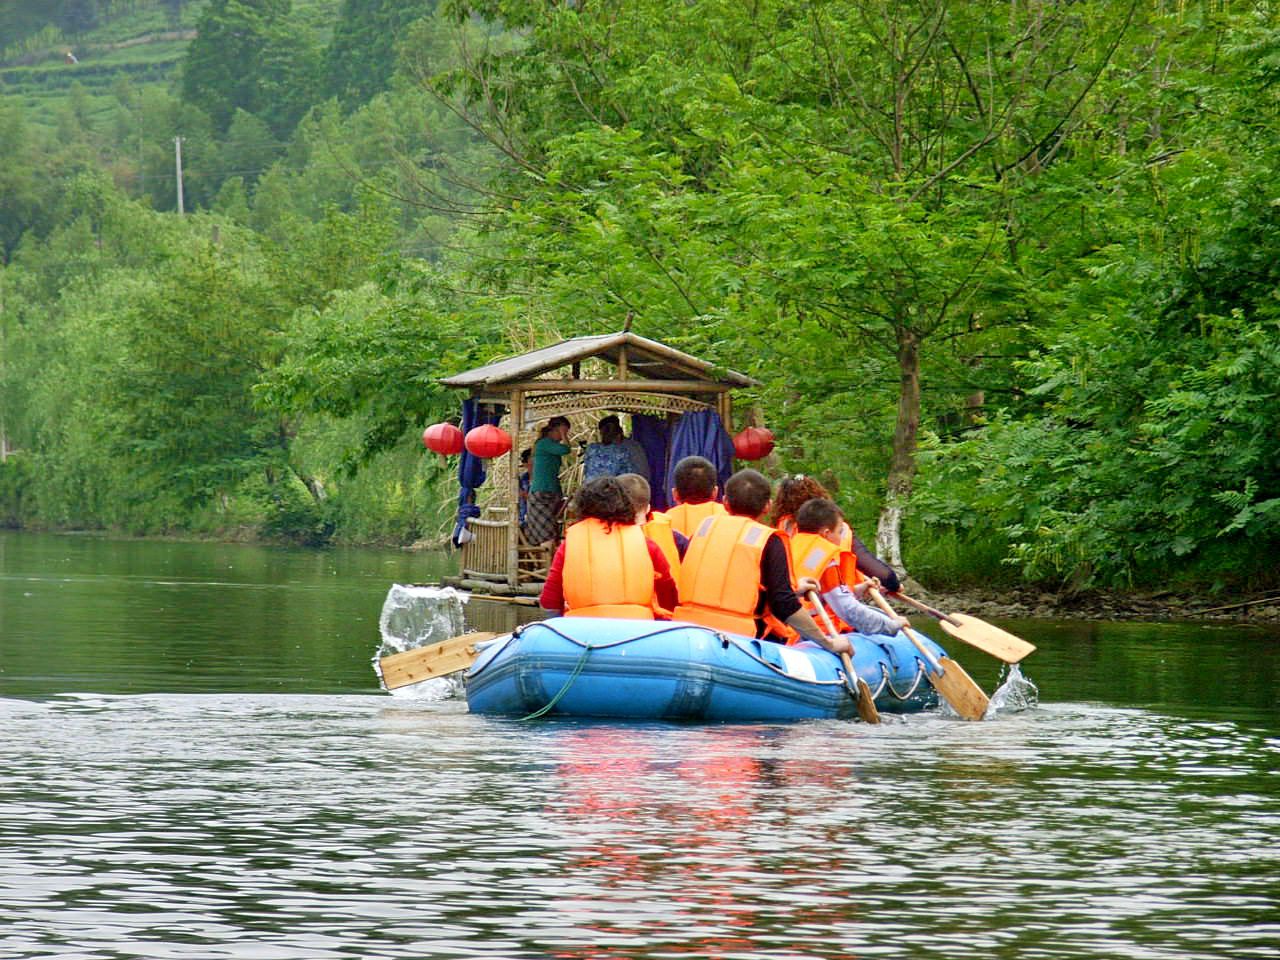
[463,617,946,722]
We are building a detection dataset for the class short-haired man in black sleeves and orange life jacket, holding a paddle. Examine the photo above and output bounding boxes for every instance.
[675,470,852,653]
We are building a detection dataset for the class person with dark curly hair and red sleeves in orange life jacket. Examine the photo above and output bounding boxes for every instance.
[538,476,677,620]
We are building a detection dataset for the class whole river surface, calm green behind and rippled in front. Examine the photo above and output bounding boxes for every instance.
[0,531,1280,960]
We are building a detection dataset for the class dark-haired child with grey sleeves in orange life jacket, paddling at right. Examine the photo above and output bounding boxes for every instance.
[791,498,910,636]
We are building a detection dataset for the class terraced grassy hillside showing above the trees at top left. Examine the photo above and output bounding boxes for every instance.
[0,0,340,127]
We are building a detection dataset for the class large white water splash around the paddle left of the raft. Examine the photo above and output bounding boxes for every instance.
[374,584,468,700]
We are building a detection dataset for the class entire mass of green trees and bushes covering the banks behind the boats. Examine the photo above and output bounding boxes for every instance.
[0,0,1280,601]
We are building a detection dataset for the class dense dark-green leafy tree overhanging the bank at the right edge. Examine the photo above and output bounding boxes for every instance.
[911,14,1280,586]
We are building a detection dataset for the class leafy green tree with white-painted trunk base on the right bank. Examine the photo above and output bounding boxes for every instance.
[424,0,1137,563]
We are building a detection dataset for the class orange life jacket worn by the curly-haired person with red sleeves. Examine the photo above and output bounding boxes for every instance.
[564,517,654,620]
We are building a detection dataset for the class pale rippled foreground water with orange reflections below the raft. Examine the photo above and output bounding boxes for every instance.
[0,694,1280,960]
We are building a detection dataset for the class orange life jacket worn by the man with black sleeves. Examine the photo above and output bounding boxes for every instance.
[672,513,795,637]
